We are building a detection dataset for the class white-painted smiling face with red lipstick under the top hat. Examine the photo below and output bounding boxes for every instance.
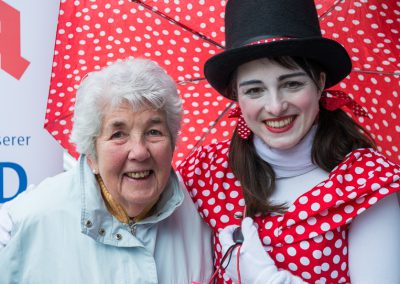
[237,58,325,149]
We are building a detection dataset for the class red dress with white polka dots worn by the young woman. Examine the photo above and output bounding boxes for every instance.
[178,141,400,283]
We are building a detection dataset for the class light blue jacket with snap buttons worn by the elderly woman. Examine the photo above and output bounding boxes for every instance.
[0,157,212,284]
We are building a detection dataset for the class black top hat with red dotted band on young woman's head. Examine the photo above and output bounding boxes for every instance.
[204,0,351,99]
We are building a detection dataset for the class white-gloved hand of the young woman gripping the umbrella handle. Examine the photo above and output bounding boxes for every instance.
[219,217,307,284]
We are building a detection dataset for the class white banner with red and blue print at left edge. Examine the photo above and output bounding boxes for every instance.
[0,0,63,203]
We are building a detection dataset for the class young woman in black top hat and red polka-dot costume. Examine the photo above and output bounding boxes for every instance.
[179,0,400,284]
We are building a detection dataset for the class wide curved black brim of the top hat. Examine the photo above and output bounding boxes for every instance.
[204,37,351,99]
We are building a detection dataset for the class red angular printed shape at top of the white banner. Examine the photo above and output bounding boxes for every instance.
[0,0,29,80]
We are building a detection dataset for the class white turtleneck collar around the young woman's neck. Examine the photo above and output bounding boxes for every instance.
[253,125,317,178]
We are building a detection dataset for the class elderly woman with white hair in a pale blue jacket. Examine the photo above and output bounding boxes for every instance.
[0,59,212,284]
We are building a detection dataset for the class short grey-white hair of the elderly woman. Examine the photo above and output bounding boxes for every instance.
[70,58,182,157]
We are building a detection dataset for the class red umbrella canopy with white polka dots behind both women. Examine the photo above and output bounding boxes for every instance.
[45,0,400,165]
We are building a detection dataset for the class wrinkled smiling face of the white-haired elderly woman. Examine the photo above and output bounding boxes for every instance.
[89,103,173,217]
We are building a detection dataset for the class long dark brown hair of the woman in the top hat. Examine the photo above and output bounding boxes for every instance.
[227,57,375,217]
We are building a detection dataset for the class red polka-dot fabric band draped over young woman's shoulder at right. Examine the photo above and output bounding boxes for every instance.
[282,148,400,241]
